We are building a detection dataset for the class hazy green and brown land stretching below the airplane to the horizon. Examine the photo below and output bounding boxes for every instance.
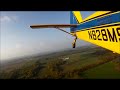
[0,46,120,79]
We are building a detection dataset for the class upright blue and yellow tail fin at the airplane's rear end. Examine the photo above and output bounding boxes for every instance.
[70,11,82,32]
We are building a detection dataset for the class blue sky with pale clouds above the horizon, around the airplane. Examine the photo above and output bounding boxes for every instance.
[0,11,94,61]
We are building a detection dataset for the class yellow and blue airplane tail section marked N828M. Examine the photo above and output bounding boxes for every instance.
[30,11,120,54]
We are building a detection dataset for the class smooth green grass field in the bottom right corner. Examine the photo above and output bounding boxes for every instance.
[84,62,120,79]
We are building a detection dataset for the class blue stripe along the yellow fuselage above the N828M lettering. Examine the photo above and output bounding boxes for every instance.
[75,13,120,31]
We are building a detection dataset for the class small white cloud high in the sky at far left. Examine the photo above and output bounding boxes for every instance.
[0,15,18,23]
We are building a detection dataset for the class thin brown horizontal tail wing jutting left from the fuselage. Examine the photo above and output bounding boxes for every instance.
[30,24,77,28]
